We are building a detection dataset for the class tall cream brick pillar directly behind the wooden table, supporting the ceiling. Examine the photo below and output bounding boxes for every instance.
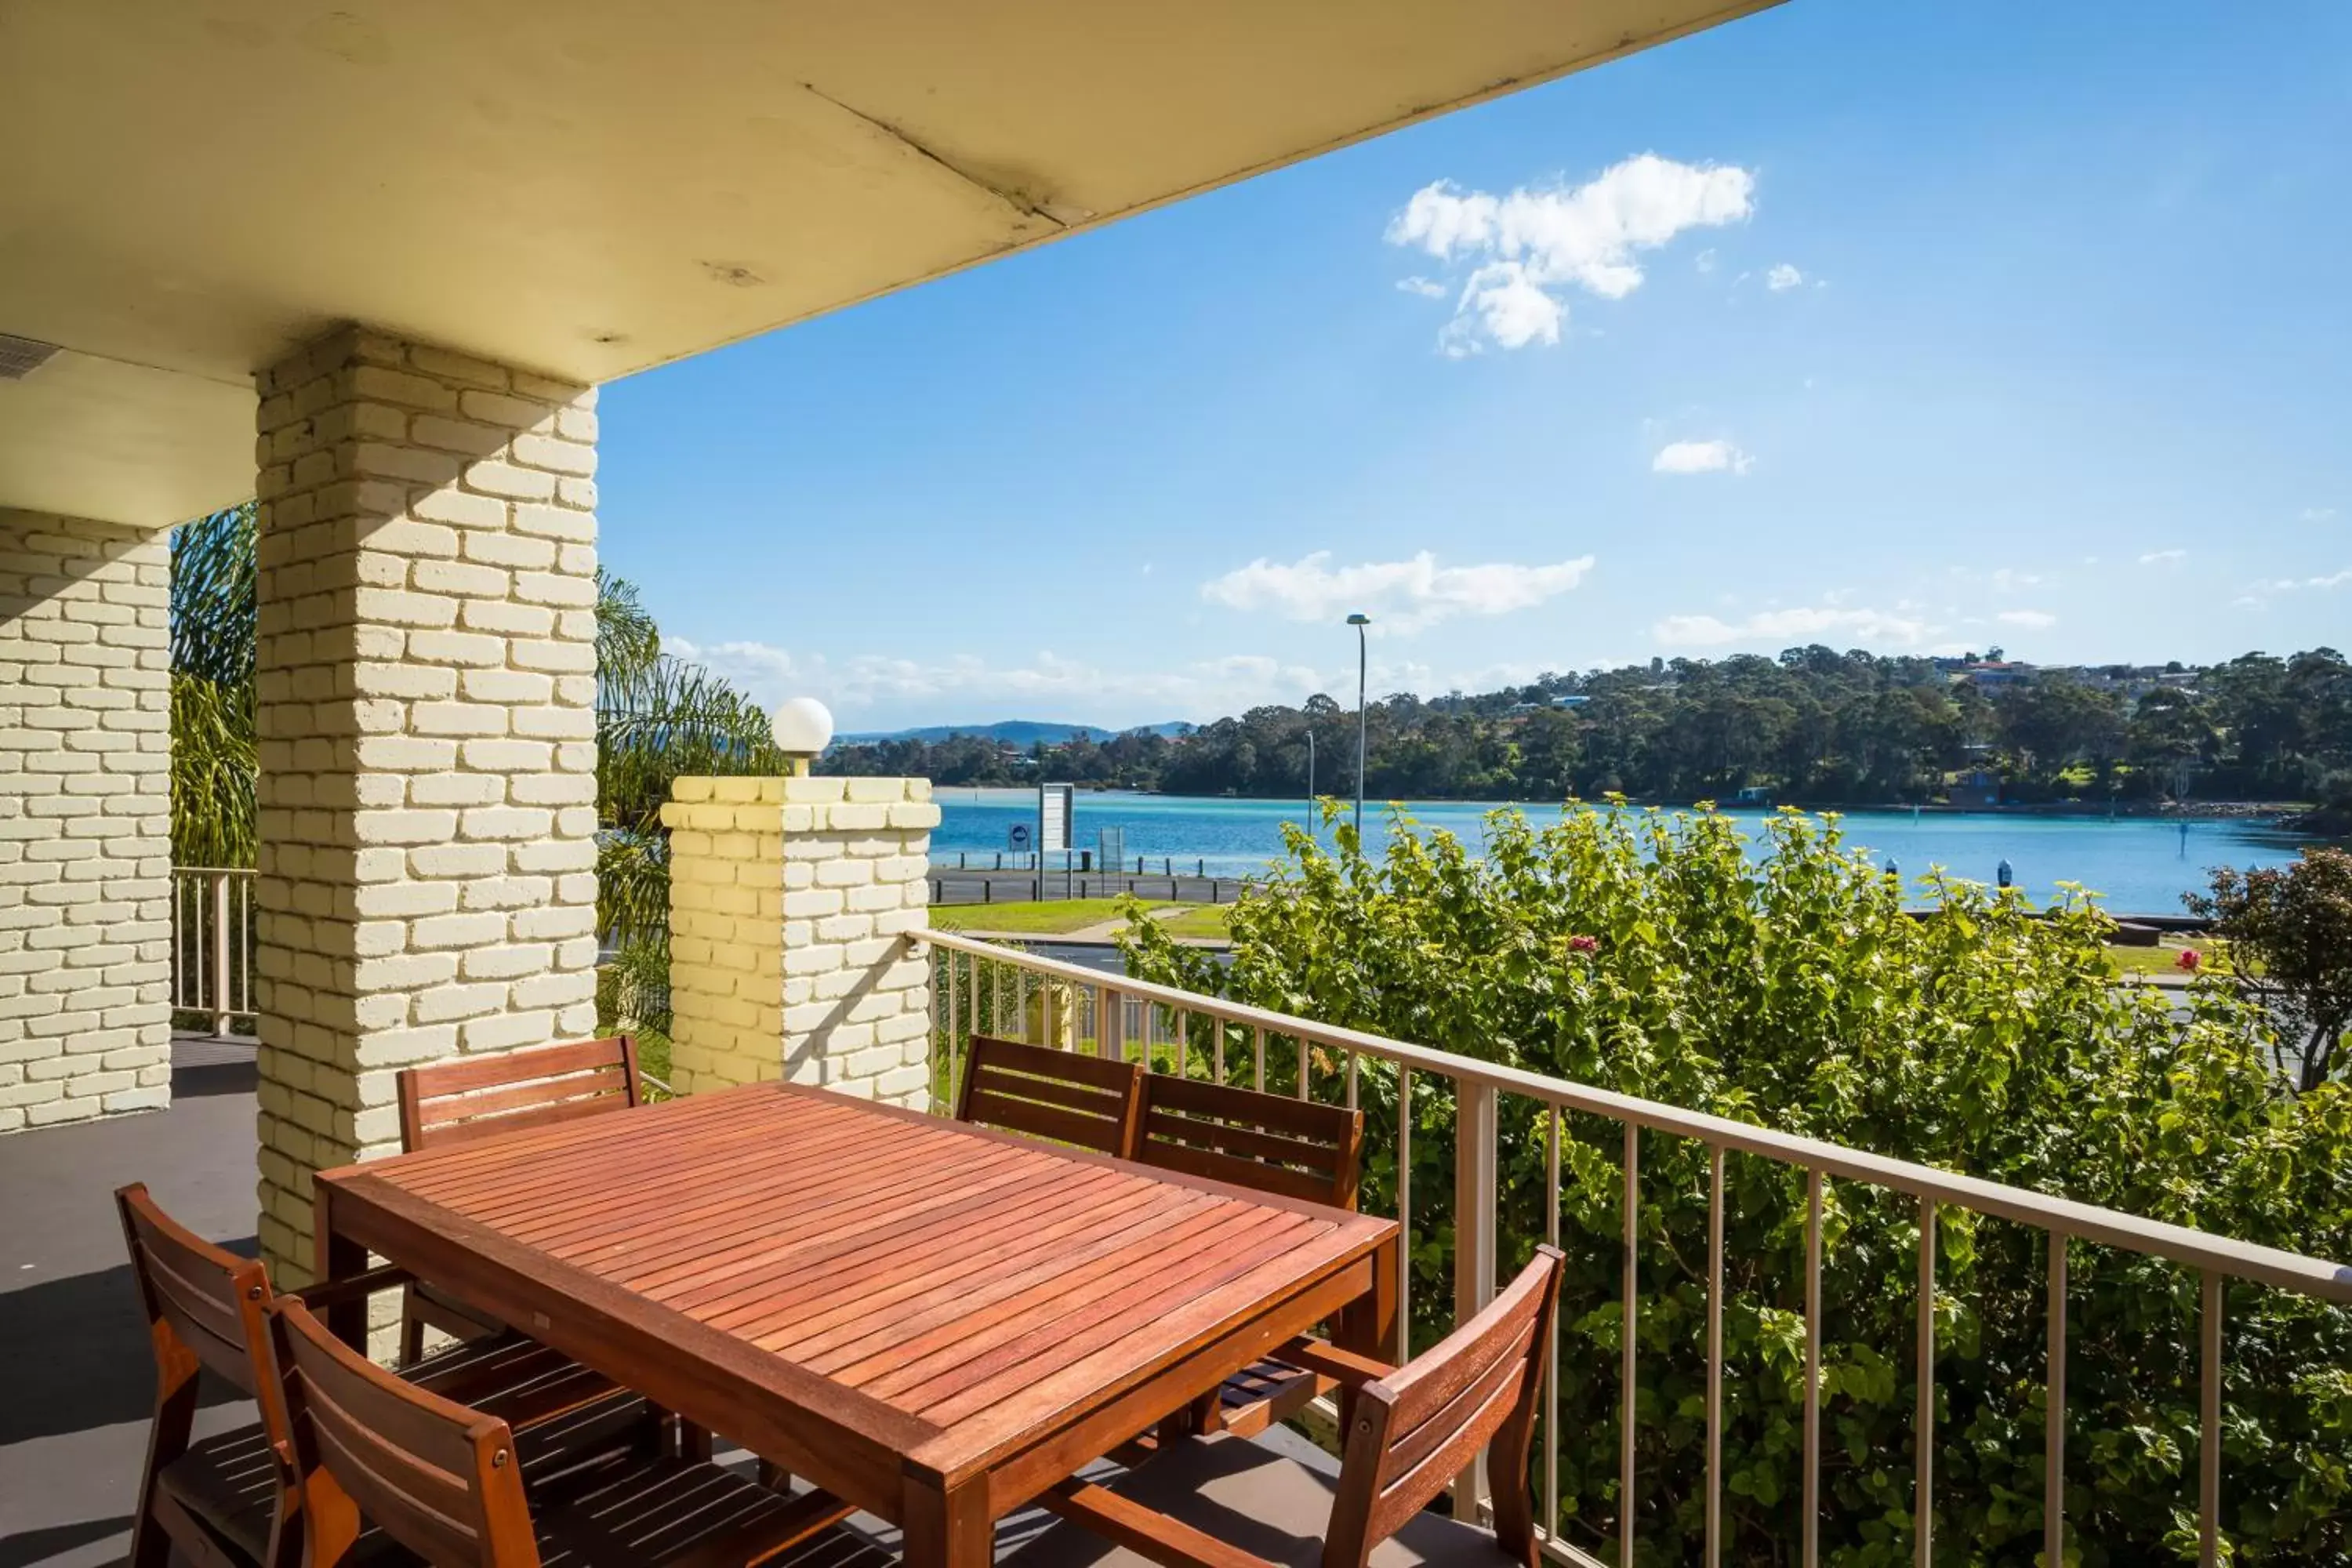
[256,329,597,1279]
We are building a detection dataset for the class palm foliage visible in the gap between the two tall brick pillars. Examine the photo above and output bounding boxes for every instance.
[172,501,259,865]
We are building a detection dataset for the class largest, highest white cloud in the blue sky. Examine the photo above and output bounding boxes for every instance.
[1385,153,1755,358]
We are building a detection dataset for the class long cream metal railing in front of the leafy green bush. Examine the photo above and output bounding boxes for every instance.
[908,931,2352,1568]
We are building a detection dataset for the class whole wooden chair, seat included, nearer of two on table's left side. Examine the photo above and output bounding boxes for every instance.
[270,1300,882,1568]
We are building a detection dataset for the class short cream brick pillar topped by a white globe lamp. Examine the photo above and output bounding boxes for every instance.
[661,779,938,1107]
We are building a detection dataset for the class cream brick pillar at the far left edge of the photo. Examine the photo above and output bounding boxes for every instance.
[0,510,172,1133]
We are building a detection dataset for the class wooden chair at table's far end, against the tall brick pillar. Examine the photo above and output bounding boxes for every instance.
[397,1034,644,1363]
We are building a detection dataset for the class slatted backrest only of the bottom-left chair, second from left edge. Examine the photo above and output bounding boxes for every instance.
[273,1298,536,1568]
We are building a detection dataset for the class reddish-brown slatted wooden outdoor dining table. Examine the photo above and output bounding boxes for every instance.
[318,1083,1397,1568]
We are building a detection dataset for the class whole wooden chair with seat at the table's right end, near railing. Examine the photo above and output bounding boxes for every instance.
[1025,1246,1562,1568]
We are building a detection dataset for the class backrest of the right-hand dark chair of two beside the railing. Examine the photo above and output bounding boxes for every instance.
[1136,1074,1364,1208]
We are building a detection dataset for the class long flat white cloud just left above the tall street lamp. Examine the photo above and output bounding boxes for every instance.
[1200,550,1592,633]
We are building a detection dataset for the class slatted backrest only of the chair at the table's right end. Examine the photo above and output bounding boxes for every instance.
[1324,1246,1562,1568]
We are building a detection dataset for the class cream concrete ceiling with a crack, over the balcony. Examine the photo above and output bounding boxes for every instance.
[0,0,1769,524]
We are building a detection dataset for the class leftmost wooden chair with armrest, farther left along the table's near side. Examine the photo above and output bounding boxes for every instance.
[115,1182,649,1568]
